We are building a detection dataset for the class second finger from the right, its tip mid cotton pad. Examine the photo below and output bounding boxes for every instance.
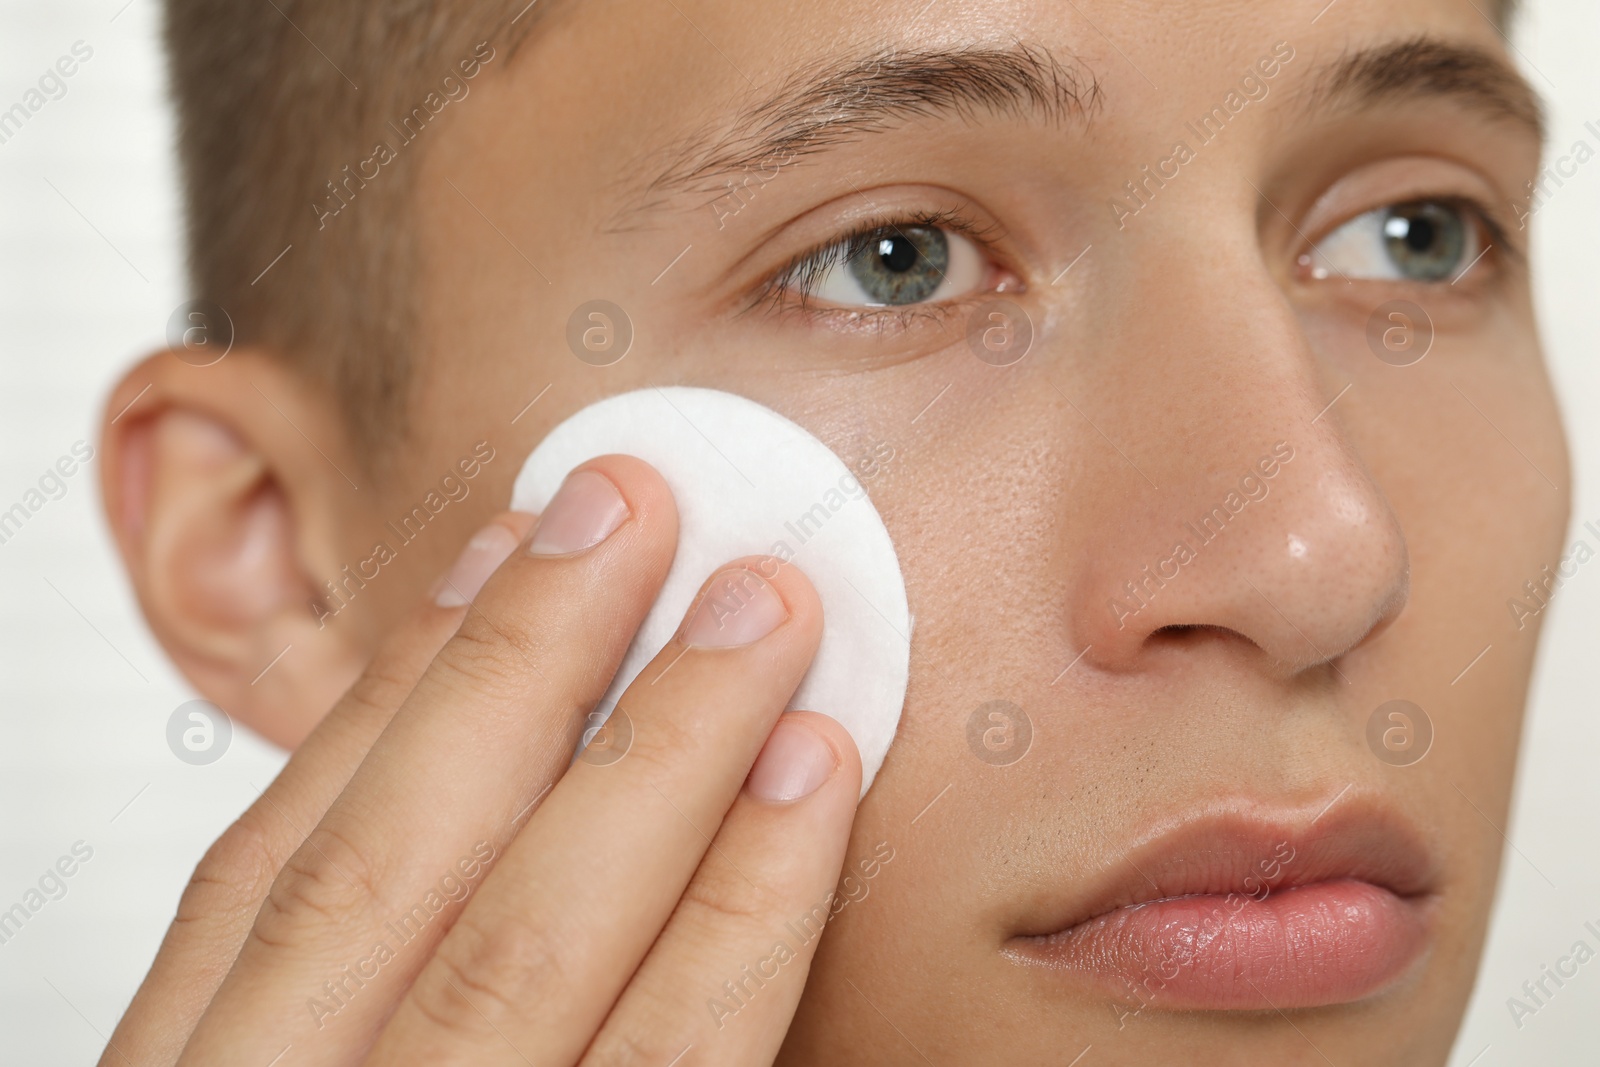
[373,557,822,1064]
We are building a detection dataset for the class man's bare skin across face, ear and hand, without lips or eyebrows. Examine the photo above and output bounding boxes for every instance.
[102,0,1568,1064]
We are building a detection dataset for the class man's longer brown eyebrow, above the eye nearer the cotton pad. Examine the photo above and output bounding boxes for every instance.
[617,43,1101,219]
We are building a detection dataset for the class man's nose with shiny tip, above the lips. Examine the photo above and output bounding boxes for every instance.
[1067,245,1410,673]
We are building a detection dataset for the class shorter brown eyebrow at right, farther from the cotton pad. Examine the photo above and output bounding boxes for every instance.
[1302,35,1546,144]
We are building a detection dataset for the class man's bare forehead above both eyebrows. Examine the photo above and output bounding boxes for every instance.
[517,0,1504,131]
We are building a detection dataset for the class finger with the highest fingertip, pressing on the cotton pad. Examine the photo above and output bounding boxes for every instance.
[182,456,677,1064]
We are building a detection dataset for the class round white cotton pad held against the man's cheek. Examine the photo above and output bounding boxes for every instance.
[510,386,910,795]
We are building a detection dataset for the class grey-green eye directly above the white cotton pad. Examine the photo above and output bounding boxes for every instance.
[778,222,989,307]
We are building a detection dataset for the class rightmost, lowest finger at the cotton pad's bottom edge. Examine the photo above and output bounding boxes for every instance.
[582,712,877,1067]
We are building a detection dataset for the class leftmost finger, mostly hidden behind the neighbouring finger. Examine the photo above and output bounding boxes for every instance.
[102,512,534,1064]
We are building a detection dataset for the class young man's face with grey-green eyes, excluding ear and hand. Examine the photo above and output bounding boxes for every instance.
[344,0,1566,1064]
